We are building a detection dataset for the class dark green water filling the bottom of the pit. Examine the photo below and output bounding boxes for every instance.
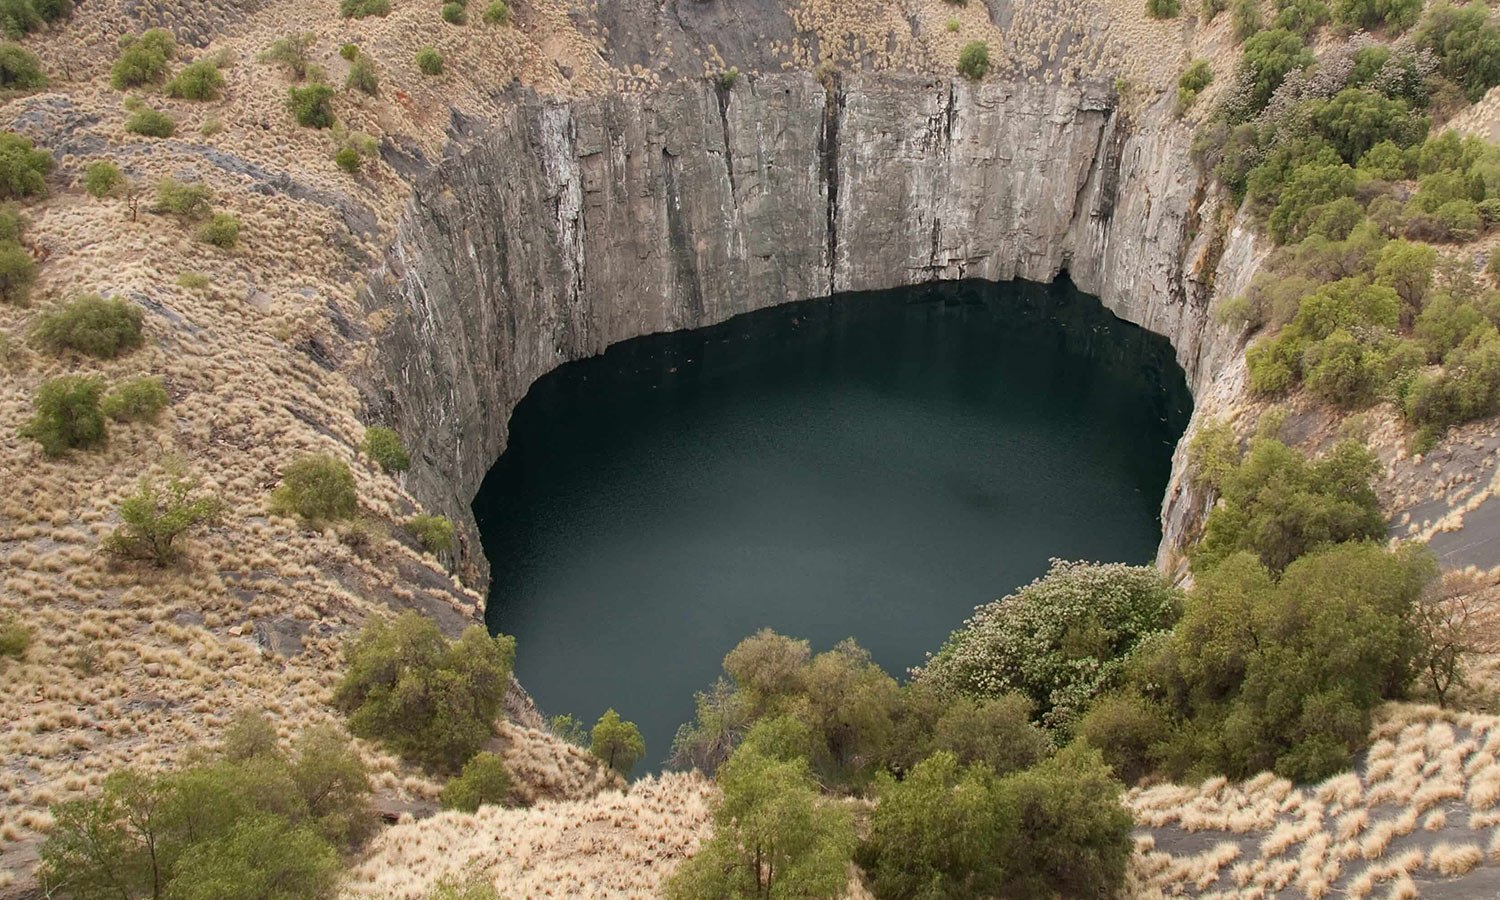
[474,282,1191,771]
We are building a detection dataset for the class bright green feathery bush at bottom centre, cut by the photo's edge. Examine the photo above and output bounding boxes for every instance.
[663,746,855,900]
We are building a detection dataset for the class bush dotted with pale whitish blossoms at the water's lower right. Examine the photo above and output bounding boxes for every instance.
[914,560,1181,732]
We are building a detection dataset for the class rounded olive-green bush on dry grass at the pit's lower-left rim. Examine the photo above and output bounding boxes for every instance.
[333,612,516,773]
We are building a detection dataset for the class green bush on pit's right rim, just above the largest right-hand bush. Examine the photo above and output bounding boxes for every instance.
[1193,438,1386,572]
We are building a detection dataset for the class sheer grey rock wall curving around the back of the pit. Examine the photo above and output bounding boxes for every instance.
[366,74,1259,584]
